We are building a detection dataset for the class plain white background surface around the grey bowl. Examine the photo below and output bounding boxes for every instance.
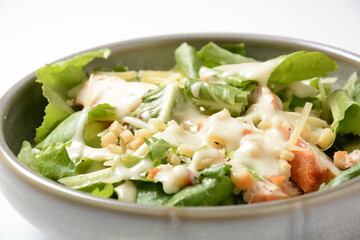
[0,0,360,240]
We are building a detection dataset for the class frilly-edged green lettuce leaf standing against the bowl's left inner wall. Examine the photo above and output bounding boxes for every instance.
[35,49,110,143]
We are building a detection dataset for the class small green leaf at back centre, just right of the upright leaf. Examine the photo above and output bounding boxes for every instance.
[197,42,254,68]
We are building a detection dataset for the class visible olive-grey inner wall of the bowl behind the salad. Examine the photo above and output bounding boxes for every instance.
[0,34,360,214]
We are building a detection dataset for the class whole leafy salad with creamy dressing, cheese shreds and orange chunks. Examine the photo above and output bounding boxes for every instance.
[18,42,360,206]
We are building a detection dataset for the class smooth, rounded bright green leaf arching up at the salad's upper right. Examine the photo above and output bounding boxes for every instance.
[269,51,338,83]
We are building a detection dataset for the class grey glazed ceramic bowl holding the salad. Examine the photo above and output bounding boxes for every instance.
[0,33,360,240]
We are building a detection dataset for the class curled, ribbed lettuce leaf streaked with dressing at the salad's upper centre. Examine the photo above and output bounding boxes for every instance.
[183,79,250,117]
